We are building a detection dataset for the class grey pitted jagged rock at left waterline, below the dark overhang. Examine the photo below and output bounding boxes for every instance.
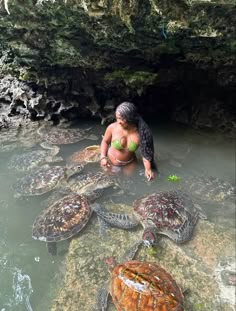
[0,75,91,125]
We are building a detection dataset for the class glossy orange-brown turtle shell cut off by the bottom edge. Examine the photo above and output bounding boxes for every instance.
[110,260,184,311]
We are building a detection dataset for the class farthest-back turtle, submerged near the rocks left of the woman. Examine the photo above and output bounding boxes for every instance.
[37,125,98,145]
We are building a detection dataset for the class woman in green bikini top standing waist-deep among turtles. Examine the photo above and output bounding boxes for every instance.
[101,102,156,180]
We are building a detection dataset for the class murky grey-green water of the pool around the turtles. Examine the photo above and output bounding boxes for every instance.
[0,121,235,311]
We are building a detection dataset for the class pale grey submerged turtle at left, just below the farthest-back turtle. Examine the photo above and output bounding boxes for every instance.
[8,142,63,171]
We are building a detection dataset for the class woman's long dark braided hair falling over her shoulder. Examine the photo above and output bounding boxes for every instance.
[116,102,156,169]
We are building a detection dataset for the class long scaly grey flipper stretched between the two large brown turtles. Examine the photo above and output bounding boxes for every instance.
[92,203,139,229]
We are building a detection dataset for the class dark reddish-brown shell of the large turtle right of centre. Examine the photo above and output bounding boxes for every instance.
[133,191,199,243]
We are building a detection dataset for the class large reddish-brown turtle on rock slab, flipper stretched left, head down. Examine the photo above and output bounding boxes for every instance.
[93,191,204,246]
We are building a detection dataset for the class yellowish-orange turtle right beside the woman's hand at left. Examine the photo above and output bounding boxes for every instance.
[68,145,101,164]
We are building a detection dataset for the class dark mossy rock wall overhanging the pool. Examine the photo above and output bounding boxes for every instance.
[0,0,236,133]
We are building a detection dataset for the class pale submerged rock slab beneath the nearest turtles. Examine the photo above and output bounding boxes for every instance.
[51,204,235,311]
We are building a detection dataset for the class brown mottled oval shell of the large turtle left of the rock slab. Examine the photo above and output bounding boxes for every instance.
[32,193,92,242]
